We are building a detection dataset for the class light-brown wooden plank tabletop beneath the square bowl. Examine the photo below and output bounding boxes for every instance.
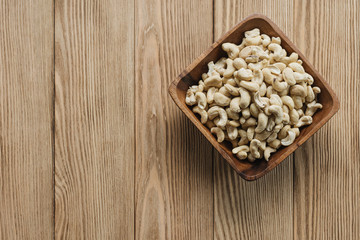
[0,0,360,240]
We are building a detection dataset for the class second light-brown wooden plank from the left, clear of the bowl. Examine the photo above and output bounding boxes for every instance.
[55,0,135,239]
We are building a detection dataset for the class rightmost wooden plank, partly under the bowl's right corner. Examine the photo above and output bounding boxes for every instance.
[294,0,360,239]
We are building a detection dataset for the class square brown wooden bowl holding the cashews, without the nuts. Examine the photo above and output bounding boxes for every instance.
[169,14,340,180]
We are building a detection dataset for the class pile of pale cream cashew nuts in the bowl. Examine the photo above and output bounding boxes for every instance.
[185,28,322,162]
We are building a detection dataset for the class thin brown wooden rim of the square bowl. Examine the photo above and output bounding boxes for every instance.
[168,13,340,181]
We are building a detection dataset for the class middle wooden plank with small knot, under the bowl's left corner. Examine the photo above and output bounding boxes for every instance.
[135,0,213,239]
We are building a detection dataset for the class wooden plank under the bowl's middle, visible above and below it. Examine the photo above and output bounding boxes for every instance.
[214,0,294,239]
